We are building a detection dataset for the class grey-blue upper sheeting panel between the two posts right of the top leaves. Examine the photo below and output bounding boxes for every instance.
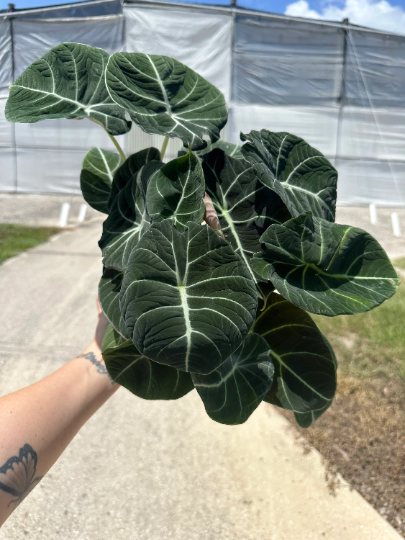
[232,15,344,106]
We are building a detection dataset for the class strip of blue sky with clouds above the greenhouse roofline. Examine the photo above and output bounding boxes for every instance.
[0,0,405,34]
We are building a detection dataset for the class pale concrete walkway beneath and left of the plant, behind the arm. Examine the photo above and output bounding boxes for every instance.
[0,221,400,540]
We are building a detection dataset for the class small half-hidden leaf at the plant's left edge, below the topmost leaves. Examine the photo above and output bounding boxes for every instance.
[80,148,122,214]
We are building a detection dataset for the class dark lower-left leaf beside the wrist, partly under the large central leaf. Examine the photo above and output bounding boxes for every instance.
[102,325,194,400]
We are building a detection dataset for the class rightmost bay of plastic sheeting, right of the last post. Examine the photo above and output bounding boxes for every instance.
[335,30,405,206]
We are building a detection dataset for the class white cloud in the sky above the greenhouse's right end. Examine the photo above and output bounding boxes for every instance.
[285,0,405,34]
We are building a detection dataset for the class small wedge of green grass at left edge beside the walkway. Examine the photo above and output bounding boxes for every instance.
[0,223,59,264]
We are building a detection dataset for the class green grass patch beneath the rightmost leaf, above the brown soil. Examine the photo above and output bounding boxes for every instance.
[313,285,405,383]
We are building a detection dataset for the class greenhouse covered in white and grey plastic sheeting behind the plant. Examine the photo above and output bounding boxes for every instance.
[0,0,405,206]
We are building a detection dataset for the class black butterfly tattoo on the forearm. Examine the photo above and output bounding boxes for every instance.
[0,444,43,506]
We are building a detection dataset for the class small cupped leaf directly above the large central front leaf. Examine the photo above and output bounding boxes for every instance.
[146,151,205,231]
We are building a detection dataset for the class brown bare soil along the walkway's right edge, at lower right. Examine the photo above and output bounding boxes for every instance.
[279,378,405,538]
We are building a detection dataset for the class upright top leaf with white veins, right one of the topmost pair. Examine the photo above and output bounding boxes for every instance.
[106,53,228,149]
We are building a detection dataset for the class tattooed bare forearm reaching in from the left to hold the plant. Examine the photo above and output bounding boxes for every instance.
[0,342,119,525]
